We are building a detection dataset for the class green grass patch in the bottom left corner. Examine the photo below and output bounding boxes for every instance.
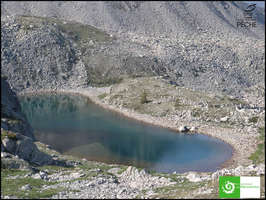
[1,169,63,199]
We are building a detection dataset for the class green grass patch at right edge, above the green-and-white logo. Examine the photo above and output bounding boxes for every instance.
[249,127,265,164]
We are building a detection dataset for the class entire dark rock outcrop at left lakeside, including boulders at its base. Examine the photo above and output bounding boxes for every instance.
[1,77,55,168]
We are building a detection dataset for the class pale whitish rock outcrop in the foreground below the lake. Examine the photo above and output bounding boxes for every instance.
[32,166,176,199]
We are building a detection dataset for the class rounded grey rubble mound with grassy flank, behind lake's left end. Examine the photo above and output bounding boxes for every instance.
[1,16,166,91]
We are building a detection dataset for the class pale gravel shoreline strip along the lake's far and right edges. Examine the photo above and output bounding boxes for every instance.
[18,87,254,173]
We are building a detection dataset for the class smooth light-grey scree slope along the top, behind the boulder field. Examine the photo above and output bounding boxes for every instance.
[1,1,265,37]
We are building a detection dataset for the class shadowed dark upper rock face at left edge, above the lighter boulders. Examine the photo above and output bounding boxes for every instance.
[1,77,35,140]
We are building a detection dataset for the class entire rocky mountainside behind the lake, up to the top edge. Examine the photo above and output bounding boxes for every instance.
[1,2,265,96]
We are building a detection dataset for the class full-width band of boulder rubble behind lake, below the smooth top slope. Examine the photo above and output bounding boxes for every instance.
[1,12,265,96]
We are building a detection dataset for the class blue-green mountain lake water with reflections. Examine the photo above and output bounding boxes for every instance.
[20,94,232,172]
